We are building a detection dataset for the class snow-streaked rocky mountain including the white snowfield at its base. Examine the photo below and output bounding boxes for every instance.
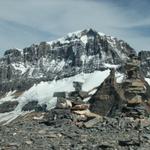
[0,29,150,123]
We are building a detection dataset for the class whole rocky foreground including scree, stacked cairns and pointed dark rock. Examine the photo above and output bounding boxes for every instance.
[0,53,150,150]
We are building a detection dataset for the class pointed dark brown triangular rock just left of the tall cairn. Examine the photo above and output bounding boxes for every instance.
[89,70,123,116]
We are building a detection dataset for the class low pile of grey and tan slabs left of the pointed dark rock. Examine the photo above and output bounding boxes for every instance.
[41,99,102,128]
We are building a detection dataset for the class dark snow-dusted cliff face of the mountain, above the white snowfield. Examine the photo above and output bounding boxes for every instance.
[0,29,134,92]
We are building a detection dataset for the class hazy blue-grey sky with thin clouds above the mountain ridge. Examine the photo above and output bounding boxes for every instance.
[0,0,150,54]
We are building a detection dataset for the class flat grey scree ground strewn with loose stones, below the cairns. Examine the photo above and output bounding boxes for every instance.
[0,109,150,150]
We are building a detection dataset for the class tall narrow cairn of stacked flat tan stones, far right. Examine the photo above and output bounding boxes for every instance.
[123,54,146,117]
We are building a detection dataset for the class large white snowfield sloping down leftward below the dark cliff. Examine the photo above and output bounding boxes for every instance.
[0,70,110,123]
